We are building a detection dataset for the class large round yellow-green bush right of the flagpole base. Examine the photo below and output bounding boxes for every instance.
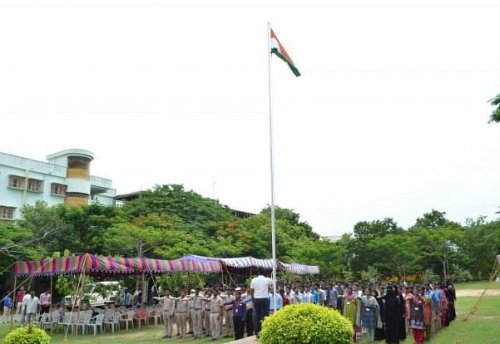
[260,303,353,344]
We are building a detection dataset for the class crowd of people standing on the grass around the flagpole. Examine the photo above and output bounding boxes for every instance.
[3,275,456,344]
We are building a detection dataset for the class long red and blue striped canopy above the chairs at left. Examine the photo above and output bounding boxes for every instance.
[15,253,222,277]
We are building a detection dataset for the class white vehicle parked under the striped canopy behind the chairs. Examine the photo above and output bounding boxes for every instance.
[62,281,121,309]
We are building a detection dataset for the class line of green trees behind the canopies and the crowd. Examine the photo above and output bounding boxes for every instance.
[0,185,500,280]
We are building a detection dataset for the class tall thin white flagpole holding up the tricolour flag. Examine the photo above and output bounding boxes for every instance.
[267,22,276,310]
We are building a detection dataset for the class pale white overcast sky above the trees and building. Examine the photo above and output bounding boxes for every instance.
[0,0,500,236]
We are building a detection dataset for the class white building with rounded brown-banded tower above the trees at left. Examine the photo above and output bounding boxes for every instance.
[0,149,116,220]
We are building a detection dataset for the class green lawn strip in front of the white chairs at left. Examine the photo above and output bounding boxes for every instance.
[0,325,232,344]
